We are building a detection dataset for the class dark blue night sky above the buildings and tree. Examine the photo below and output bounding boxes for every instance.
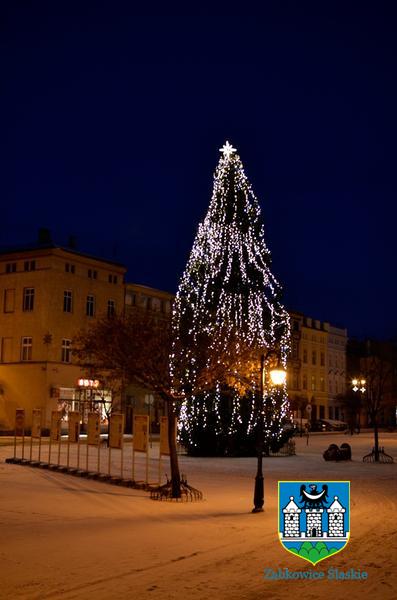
[0,0,397,337]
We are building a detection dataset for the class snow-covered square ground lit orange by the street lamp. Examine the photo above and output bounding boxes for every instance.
[0,433,397,600]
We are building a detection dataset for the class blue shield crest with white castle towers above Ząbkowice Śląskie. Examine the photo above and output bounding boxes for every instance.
[278,481,350,565]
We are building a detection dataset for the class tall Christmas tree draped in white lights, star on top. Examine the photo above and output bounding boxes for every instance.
[171,142,289,454]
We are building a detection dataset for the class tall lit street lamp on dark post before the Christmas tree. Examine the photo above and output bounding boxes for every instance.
[252,350,287,513]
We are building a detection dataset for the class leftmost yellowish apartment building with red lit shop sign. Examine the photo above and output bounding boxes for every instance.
[0,243,126,430]
